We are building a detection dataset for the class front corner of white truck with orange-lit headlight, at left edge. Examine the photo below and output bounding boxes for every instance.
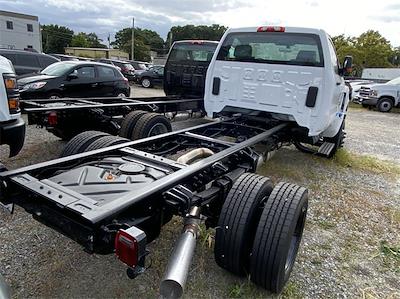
[0,56,25,157]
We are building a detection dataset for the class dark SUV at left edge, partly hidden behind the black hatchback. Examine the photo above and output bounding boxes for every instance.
[0,49,60,75]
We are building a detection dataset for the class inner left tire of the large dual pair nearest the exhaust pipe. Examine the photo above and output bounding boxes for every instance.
[214,173,273,275]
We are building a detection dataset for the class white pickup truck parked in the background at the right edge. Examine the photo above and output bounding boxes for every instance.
[353,77,400,112]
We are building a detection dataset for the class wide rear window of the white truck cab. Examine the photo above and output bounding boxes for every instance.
[217,32,324,67]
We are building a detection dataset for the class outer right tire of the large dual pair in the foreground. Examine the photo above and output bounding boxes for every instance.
[250,183,308,293]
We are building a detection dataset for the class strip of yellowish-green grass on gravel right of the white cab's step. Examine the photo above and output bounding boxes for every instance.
[331,149,400,175]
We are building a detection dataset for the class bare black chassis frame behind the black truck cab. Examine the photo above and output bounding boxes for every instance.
[21,96,204,140]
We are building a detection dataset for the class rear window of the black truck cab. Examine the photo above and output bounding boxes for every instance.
[168,43,217,62]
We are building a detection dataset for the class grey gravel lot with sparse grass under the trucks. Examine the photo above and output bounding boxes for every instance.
[0,88,400,298]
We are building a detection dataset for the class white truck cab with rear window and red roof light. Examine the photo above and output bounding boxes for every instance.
[204,27,352,156]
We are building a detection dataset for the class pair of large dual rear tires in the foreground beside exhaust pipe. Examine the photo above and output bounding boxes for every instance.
[214,173,308,293]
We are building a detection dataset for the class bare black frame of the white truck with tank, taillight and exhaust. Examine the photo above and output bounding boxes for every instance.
[0,115,306,297]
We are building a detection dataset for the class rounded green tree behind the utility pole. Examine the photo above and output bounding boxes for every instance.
[111,28,164,61]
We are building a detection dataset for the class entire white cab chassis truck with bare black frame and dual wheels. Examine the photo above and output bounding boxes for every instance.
[0,27,351,298]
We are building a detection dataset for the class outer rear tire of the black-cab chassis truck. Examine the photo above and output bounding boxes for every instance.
[129,113,172,140]
